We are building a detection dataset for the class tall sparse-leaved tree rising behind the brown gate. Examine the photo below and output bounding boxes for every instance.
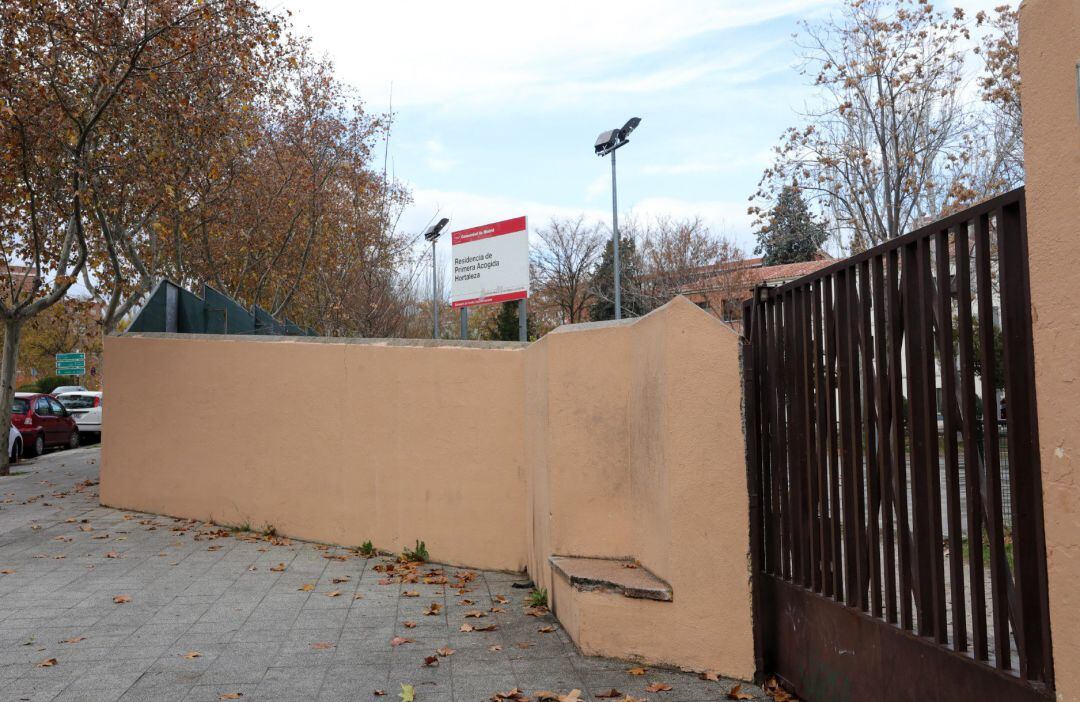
[751,0,971,251]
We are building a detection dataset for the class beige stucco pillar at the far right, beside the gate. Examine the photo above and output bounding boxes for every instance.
[1020,0,1080,700]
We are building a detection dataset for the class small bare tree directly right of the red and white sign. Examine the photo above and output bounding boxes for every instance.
[531,215,604,324]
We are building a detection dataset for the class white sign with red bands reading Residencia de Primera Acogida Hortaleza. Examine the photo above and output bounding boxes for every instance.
[450,217,529,307]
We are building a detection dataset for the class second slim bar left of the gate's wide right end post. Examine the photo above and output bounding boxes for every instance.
[954,216,988,661]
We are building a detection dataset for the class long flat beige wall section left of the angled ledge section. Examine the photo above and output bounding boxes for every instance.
[102,336,527,570]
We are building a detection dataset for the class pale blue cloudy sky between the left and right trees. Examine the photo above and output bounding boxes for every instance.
[268,0,994,257]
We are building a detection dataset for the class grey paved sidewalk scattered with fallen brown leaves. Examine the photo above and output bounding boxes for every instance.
[0,447,764,702]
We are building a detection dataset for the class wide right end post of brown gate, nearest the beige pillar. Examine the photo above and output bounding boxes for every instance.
[998,194,1053,683]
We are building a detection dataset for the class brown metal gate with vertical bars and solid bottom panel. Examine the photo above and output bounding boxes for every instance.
[743,189,1053,702]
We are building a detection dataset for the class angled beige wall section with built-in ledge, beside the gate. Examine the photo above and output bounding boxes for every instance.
[526,298,754,678]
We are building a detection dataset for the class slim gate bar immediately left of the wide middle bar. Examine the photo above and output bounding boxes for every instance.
[888,249,913,631]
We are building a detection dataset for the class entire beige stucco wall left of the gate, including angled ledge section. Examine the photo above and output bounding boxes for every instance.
[102,298,754,678]
